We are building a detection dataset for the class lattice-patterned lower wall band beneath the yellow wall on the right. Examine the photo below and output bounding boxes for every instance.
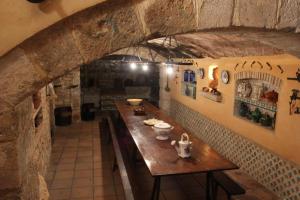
[171,100,300,200]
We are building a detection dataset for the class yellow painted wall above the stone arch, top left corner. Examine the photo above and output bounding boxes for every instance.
[0,0,105,56]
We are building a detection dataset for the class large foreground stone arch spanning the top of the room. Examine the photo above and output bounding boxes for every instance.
[0,0,299,114]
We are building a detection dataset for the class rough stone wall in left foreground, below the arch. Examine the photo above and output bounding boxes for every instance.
[0,88,51,200]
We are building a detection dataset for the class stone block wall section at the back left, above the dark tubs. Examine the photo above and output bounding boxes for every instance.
[54,69,81,122]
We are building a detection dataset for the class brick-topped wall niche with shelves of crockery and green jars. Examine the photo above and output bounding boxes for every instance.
[234,73,281,130]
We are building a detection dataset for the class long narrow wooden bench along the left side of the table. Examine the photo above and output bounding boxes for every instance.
[103,116,134,200]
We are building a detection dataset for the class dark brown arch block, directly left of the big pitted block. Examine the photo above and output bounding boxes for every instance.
[20,22,83,80]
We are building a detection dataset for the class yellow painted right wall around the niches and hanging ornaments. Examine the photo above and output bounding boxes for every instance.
[171,55,300,165]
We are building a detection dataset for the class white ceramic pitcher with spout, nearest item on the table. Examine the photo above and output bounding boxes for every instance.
[171,133,192,158]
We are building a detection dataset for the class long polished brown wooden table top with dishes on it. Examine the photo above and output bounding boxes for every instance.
[116,101,238,176]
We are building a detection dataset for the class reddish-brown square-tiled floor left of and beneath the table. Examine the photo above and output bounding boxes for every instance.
[47,121,224,200]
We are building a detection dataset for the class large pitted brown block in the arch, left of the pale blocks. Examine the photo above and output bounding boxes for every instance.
[68,2,143,62]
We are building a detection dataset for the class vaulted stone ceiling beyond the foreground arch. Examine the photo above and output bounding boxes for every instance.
[114,29,300,61]
